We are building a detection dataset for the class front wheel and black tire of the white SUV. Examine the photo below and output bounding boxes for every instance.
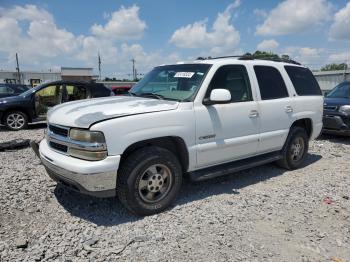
[117,146,182,216]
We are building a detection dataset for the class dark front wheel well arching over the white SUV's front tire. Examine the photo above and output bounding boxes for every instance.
[121,136,189,172]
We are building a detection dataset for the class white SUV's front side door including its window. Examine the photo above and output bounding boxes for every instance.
[195,65,259,168]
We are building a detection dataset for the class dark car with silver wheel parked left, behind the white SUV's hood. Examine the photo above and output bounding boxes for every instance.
[0,81,111,130]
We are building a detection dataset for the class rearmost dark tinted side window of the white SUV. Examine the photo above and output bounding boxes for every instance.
[284,66,322,96]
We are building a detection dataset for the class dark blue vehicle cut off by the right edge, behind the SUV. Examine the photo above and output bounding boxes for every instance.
[323,82,350,135]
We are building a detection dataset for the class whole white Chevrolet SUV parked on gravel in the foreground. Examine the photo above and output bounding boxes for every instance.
[33,57,323,215]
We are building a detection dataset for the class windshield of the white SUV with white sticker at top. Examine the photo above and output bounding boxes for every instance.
[130,64,211,101]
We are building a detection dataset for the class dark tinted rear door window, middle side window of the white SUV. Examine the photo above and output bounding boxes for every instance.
[254,66,289,100]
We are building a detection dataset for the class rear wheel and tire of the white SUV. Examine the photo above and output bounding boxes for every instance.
[276,127,309,170]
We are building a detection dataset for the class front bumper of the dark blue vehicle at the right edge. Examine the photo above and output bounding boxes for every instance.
[322,114,350,135]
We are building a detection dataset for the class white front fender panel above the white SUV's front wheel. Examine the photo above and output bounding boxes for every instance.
[90,107,195,155]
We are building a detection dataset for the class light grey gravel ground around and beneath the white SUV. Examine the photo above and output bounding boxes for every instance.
[0,125,350,262]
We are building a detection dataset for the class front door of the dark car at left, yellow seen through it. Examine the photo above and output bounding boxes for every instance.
[35,85,63,120]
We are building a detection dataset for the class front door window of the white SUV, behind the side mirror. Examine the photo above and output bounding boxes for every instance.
[206,65,253,102]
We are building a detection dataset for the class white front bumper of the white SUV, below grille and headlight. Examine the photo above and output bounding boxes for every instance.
[38,139,120,197]
